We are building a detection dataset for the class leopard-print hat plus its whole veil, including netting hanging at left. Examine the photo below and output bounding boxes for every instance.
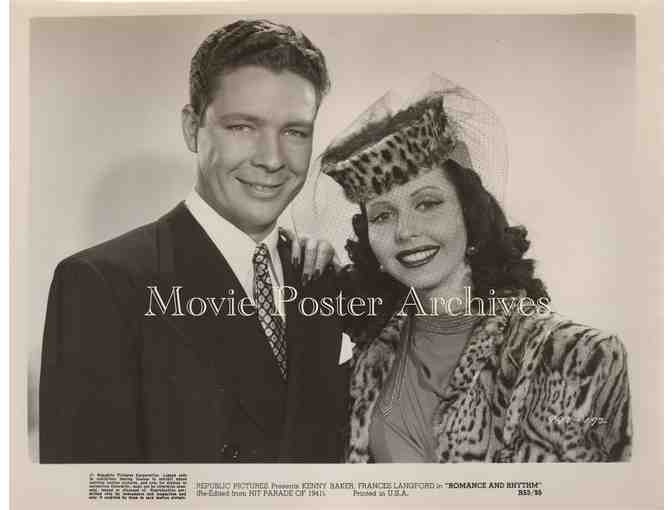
[288,74,508,270]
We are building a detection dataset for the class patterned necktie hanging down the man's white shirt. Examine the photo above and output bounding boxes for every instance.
[252,244,287,381]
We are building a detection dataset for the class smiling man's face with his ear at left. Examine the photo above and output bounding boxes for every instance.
[183,66,318,241]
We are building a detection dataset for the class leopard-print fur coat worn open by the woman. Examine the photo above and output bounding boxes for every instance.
[346,306,632,462]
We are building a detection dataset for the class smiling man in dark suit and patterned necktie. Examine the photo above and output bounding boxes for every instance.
[40,20,347,463]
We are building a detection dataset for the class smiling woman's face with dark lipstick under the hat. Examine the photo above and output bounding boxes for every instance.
[366,167,467,294]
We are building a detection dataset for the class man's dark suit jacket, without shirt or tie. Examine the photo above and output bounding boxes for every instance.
[40,204,348,463]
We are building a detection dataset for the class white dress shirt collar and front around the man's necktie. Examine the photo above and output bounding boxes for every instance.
[184,190,285,318]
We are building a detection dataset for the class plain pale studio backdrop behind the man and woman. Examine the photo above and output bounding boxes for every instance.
[30,14,644,459]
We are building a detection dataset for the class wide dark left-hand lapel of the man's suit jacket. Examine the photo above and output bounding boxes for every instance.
[154,204,286,430]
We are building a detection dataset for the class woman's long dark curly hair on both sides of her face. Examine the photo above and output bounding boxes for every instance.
[346,159,549,335]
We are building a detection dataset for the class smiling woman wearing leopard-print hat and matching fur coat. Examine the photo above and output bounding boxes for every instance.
[320,77,631,462]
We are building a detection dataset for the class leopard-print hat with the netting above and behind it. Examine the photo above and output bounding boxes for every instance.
[320,75,507,203]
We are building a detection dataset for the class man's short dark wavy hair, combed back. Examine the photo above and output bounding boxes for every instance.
[189,20,330,116]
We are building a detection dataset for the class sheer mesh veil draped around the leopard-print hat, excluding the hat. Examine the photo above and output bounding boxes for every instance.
[290,74,508,263]
